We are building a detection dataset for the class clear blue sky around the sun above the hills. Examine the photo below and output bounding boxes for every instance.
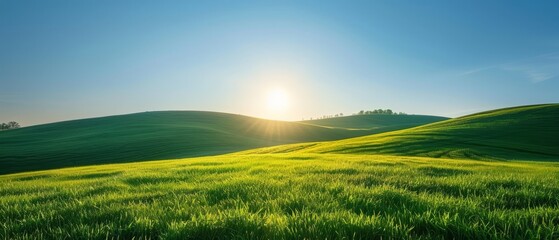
[0,0,559,125]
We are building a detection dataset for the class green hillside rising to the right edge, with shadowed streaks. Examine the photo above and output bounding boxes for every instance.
[250,104,559,161]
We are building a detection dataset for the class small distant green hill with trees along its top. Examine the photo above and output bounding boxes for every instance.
[301,114,448,129]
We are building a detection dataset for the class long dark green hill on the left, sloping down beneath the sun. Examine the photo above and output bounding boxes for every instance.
[0,111,446,174]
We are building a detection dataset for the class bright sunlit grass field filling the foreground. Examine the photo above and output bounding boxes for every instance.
[0,153,559,239]
